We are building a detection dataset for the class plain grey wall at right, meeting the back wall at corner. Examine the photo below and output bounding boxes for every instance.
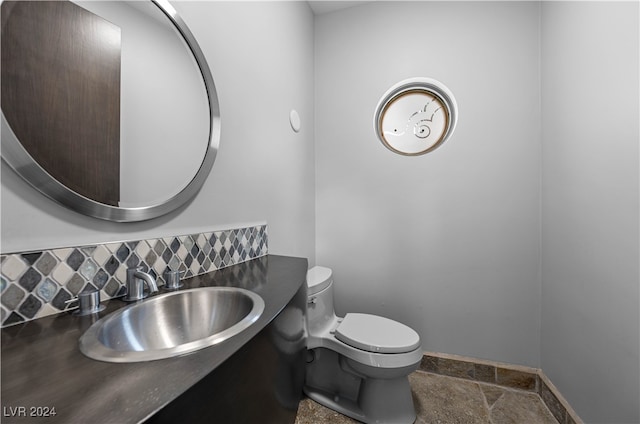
[541,2,640,424]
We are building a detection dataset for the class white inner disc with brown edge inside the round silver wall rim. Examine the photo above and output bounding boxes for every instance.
[378,88,450,156]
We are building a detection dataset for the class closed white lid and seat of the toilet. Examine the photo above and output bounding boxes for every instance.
[335,313,420,353]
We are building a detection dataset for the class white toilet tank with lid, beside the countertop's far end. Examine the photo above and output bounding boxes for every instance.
[307,266,336,335]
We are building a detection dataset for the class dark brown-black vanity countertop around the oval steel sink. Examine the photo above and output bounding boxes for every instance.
[1,255,307,424]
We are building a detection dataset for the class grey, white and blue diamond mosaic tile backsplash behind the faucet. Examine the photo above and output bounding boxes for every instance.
[0,225,268,327]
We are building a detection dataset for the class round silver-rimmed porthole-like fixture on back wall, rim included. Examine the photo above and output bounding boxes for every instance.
[374,78,458,156]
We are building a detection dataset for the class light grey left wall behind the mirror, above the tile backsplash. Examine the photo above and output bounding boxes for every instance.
[0,2,315,259]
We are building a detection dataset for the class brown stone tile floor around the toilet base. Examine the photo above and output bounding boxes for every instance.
[296,371,558,424]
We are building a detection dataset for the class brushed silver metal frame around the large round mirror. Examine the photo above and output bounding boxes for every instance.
[2,0,220,222]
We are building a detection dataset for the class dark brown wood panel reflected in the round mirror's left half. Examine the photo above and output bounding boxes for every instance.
[2,1,120,206]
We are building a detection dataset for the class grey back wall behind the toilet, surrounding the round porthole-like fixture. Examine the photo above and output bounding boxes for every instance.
[315,2,540,366]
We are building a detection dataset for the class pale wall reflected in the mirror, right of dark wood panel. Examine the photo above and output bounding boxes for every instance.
[78,1,209,207]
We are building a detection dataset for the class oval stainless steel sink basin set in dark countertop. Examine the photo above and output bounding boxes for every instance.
[80,287,264,362]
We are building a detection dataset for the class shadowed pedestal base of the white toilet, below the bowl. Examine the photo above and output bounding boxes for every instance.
[304,348,416,424]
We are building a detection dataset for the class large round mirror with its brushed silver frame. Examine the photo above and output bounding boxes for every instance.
[1,0,220,222]
